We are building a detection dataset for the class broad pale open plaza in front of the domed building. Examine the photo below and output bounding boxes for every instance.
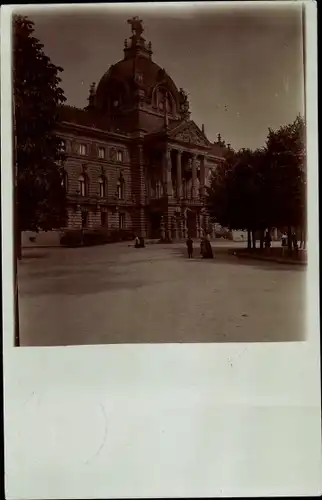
[19,243,306,346]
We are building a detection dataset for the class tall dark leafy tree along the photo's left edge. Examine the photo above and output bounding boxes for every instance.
[13,16,65,258]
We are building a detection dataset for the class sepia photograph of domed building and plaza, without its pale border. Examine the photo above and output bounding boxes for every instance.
[12,2,308,346]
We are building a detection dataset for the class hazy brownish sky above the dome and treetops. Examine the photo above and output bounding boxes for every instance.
[16,2,304,149]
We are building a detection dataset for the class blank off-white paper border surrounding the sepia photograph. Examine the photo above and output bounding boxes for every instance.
[1,1,322,500]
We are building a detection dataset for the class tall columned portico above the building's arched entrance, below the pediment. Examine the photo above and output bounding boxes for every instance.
[147,129,211,240]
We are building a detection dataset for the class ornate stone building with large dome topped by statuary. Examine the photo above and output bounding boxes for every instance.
[57,18,225,239]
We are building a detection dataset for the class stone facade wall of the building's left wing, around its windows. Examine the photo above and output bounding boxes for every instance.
[59,128,133,229]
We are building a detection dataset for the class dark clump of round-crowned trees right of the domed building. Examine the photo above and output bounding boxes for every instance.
[207,116,306,252]
